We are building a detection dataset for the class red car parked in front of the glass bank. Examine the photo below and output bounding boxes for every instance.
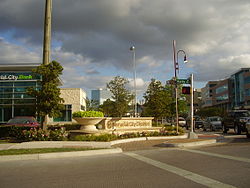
[6,116,40,127]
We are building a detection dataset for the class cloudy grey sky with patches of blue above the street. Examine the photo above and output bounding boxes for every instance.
[0,0,250,98]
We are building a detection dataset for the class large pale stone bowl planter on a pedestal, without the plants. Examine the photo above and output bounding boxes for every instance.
[73,117,103,131]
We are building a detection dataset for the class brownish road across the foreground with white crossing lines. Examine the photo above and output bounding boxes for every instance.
[0,138,250,188]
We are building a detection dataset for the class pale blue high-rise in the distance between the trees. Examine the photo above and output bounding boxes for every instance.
[91,88,112,105]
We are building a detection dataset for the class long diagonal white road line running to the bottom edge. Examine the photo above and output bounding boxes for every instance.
[124,153,236,188]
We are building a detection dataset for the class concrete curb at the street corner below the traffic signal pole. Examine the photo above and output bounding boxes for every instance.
[163,139,217,147]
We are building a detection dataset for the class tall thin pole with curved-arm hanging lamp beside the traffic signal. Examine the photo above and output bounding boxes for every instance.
[173,40,187,133]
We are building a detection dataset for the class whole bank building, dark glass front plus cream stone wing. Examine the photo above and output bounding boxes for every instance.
[0,64,86,124]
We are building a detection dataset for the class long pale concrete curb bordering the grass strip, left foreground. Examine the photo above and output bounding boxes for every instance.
[0,148,122,162]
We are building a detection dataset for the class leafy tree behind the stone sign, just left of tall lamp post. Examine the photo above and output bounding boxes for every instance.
[107,76,133,117]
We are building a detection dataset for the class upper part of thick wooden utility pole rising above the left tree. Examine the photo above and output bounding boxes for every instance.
[43,0,52,65]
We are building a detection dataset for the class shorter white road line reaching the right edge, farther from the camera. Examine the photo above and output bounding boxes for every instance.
[181,149,250,163]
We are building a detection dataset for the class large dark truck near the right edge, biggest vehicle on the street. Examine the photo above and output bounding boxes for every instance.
[222,110,250,134]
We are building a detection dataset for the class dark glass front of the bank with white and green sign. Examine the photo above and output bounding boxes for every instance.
[0,64,41,123]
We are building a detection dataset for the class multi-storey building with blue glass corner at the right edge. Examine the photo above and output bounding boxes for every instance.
[202,68,250,111]
